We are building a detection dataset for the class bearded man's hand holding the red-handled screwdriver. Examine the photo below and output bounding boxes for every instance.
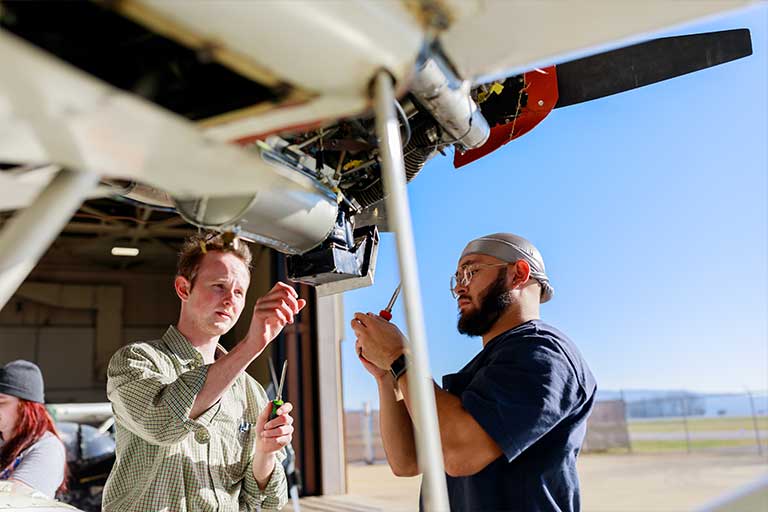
[352,313,406,376]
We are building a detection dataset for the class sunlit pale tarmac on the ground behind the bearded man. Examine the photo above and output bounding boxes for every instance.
[284,453,768,512]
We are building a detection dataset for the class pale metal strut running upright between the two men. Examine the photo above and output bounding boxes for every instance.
[374,71,449,512]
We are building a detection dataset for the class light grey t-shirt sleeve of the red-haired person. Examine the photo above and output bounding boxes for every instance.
[11,436,66,498]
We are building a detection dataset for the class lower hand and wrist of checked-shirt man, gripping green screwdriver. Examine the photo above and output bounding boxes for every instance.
[253,402,293,490]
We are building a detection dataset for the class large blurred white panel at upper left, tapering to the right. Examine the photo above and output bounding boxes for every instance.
[0,31,333,201]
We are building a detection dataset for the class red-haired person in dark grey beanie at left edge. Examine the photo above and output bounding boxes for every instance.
[0,360,67,498]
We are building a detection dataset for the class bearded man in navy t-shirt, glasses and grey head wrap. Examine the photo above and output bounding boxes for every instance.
[352,233,596,511]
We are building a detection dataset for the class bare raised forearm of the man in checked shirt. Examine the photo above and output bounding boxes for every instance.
[189,341,261,419]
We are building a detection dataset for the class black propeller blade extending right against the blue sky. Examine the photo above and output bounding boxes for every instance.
[555,29,752,108]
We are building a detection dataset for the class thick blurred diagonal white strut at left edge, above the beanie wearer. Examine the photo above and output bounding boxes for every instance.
[0,169,99,309]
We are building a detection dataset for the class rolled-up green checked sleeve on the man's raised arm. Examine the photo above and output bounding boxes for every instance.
[107,343,217,445]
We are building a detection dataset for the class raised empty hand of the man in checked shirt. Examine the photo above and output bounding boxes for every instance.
[246,282,307,350]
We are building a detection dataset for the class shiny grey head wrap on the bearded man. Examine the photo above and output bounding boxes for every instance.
[461,233,555,304]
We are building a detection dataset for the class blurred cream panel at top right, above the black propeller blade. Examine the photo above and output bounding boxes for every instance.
[439,0,752,83]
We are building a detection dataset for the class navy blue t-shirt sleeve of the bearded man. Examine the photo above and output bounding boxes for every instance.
[461,338,579,461]
